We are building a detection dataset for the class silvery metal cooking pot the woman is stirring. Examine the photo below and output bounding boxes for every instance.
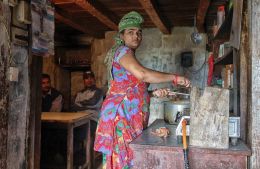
[164,100,190,124]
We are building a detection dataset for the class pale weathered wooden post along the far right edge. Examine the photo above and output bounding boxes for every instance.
[248,0,260,169]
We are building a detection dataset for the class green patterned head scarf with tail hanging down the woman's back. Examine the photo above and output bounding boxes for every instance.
[104,11,144,86]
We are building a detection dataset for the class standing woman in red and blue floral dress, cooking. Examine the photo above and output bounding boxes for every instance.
[94,11,190,169]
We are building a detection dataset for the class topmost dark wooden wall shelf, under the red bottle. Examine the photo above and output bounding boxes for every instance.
[213,8,233,42]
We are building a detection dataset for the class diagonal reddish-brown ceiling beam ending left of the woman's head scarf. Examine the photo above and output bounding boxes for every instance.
[75,0,118,31]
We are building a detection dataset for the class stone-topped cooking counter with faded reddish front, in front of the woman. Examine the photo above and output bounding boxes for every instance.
[130,120,251,169]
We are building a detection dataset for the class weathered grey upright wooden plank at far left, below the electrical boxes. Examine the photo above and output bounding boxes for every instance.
[7,46,30,169]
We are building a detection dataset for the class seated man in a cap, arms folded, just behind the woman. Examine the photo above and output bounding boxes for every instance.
[72,71,103,121]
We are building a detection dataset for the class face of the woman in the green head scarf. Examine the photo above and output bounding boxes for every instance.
[121,27,142,49]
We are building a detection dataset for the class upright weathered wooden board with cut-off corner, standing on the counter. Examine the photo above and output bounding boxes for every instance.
[190,87,229,149]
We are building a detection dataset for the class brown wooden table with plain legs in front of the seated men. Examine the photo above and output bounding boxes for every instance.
[41,112,92,169]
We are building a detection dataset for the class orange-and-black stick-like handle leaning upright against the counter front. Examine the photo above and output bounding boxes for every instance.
[182,119,190,169]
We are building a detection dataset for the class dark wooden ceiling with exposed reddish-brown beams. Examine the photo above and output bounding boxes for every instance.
[53,0,227,38]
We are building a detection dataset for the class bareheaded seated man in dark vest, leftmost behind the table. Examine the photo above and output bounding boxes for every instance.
[42,74,63,112]
